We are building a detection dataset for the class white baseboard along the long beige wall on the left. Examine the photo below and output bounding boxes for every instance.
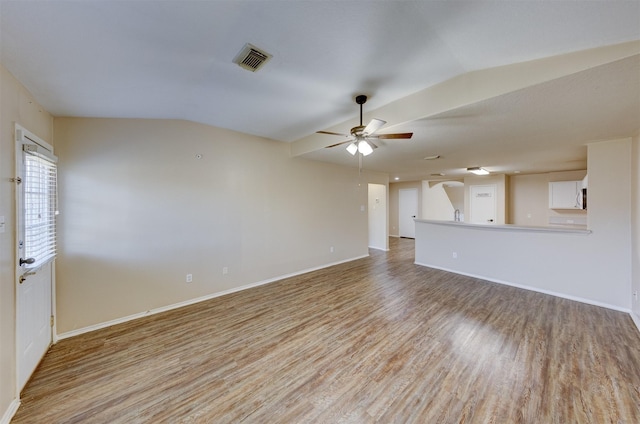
[61,254,369,341]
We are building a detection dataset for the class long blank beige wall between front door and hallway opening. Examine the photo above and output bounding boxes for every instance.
[54,118,380,333]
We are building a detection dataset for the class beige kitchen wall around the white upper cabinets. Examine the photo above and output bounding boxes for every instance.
[507,170,587,227]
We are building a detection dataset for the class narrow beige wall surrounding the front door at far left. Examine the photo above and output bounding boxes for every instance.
[0,65,53,419]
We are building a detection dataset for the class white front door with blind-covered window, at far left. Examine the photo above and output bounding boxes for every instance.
[15,125,57,393]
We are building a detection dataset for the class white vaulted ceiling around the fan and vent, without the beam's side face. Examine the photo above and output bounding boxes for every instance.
[0,0,640,180]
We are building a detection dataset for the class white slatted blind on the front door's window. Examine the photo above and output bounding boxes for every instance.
[23,149,58,268]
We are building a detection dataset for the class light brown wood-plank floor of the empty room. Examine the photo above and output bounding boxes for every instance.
[12,239,640,424]
